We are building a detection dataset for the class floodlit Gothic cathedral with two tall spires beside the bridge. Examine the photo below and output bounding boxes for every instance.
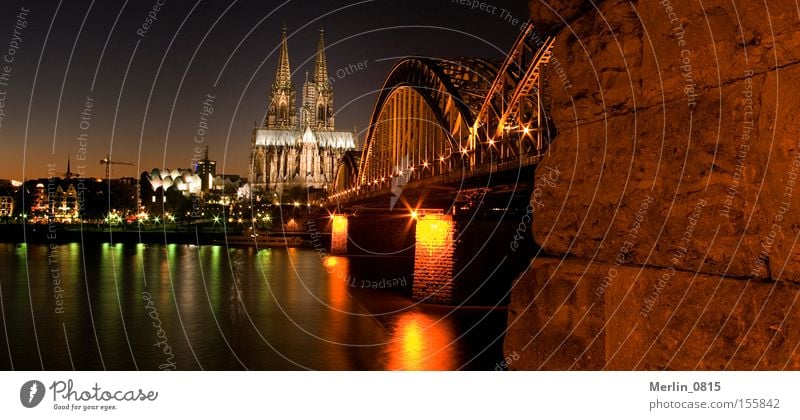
[248,28,355,193]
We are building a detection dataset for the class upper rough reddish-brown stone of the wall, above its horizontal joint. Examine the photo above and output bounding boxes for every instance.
[530,0,800,281]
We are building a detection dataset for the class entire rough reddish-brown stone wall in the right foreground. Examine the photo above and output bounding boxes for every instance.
[505,0,800,369]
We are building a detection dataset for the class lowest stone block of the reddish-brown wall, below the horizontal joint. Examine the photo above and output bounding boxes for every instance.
[504,258,800,370]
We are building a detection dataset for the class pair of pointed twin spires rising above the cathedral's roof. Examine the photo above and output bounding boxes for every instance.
[264,26,334,130]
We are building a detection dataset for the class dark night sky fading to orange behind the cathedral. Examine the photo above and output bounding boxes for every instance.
[0,0,527,180]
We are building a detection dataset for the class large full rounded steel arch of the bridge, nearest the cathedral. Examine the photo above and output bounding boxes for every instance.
[358,57,497,187]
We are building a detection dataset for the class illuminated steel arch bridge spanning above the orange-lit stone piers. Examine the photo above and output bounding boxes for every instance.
[329,23,554,203]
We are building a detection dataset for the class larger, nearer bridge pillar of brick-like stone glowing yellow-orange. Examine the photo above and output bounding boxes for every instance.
[412,214,456,304]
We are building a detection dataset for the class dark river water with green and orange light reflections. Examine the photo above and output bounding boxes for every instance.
[0,243,506,370]
